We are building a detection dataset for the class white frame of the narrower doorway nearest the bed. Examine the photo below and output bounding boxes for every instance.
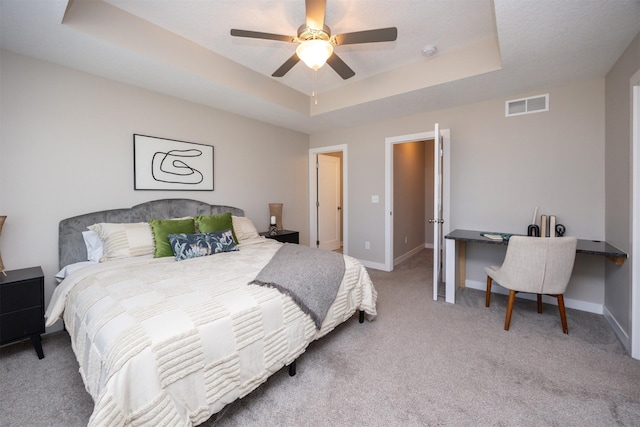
[309,144,349,255]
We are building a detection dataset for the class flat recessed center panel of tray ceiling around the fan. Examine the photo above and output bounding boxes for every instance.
[106,0,496,94]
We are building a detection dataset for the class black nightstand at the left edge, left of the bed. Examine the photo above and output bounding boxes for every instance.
[0,267,44,359]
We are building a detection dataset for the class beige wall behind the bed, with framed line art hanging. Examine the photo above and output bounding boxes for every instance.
[0,51,309,334]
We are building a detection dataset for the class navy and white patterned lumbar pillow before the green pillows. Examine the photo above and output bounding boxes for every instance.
[167,229,238,261]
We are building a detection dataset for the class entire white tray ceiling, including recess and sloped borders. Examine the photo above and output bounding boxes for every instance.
[0,0,640,133]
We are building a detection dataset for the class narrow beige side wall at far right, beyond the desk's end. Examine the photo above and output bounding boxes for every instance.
[605,30,640,346]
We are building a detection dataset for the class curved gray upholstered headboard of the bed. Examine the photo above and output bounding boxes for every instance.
[58,199,244,268]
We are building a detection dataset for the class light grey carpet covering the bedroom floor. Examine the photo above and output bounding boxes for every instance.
[0,250,640,427]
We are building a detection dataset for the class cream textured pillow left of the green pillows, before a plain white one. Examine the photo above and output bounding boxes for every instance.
[87,222,155,262]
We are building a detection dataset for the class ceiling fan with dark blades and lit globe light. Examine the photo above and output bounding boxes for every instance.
[231,0,398,80]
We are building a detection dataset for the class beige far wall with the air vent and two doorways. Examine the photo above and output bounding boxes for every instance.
[310,79,608,311]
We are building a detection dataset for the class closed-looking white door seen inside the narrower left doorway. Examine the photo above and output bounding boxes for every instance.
[317,154,342,250]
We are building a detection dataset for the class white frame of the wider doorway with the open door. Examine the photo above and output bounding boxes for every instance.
[384,129,451,272]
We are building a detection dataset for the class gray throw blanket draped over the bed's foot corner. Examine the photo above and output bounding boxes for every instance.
[249,243,345,329]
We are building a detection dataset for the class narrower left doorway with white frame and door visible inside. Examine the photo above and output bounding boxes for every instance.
[309,145,348,254]
